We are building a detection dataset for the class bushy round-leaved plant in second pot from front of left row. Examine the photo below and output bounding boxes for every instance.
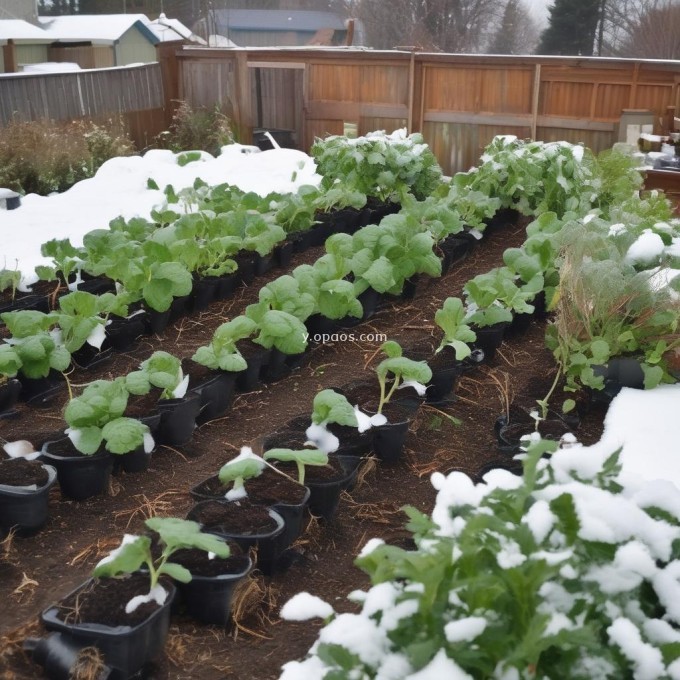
[64,377,154,455]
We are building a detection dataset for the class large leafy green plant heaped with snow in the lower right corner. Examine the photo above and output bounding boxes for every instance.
[281,441,680,680]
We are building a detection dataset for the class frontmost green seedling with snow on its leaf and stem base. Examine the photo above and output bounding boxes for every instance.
[92,517,230,614]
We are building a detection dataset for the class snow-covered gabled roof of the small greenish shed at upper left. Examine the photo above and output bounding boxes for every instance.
[39,14,161,45]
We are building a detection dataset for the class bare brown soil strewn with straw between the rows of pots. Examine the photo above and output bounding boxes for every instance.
[0,227,602,680]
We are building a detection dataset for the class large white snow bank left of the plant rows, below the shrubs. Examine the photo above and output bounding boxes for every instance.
[0,144,321,287]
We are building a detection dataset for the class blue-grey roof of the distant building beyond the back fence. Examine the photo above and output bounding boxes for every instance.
[215,9,346,33]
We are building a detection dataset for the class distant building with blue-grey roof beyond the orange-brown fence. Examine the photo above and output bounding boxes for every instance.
[194,9,364,47]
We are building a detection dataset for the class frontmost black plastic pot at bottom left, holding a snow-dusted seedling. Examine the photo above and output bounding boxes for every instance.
[40,581,176,680]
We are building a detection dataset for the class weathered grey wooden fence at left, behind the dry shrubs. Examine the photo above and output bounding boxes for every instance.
[0,62,166,148]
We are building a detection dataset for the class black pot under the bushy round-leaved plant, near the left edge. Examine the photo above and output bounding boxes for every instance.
[40,438,113,501]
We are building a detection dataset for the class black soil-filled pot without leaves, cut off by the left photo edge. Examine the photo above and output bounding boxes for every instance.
[0,464,57,536]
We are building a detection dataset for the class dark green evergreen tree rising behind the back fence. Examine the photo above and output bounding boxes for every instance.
[537,0,604,57]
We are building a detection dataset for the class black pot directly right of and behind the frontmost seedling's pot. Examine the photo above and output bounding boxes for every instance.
[177,556,253,626]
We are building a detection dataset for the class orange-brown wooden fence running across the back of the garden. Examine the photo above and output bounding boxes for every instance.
[177,48,680,173]
